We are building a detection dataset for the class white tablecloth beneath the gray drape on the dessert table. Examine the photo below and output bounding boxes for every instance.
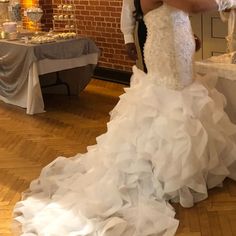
[0,53,98,115]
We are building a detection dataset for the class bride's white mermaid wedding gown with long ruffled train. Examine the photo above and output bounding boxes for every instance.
[14,0,236,236]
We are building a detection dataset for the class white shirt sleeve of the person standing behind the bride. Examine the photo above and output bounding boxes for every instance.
[120,0,135,44]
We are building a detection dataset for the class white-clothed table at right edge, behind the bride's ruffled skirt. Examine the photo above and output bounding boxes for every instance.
[195,59,236,123]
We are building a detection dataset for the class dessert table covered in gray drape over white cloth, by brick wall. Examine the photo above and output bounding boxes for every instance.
[0,38,99,114]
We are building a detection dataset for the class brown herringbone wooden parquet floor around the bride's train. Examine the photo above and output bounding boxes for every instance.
[0,80,236,236]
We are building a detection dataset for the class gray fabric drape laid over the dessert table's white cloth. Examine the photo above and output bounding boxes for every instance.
[0,38,99,98]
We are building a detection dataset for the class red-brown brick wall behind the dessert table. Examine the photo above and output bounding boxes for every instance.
[22,0,134,71]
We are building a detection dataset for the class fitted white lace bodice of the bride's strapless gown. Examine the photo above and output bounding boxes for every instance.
[144,4,195,89]
